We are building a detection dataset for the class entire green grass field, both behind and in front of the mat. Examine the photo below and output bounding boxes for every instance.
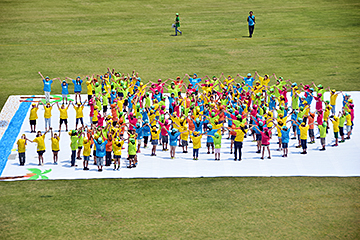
[0,0,360,239]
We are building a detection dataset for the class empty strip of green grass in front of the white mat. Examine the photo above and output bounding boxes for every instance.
[0,178,360,239]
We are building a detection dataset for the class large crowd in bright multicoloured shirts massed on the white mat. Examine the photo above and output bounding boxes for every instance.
[17,69,354,171]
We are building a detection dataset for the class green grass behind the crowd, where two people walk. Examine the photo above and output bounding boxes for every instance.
[0,0,360,107]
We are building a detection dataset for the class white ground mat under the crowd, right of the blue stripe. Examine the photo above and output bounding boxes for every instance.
[1,92,360,179]
